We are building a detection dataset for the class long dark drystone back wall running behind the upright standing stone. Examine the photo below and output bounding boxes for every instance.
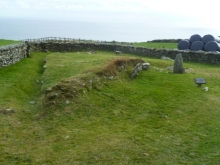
[30,43,220,65]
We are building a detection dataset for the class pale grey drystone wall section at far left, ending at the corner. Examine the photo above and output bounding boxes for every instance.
[0,44,29,68]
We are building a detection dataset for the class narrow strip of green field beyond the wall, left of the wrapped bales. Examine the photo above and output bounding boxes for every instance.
[133,42,178,49]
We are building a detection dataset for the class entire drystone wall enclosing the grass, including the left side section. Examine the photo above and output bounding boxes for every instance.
[0,42,220,68]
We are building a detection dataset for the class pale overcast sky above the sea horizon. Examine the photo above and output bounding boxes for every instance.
[0,0,220,28]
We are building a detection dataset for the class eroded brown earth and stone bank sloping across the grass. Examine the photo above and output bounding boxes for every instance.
[43,58,144,105]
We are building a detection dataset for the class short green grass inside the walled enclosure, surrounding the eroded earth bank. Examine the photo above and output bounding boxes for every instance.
[0,51,220,165]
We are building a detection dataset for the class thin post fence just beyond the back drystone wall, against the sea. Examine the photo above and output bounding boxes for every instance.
[23,37,133,46]
